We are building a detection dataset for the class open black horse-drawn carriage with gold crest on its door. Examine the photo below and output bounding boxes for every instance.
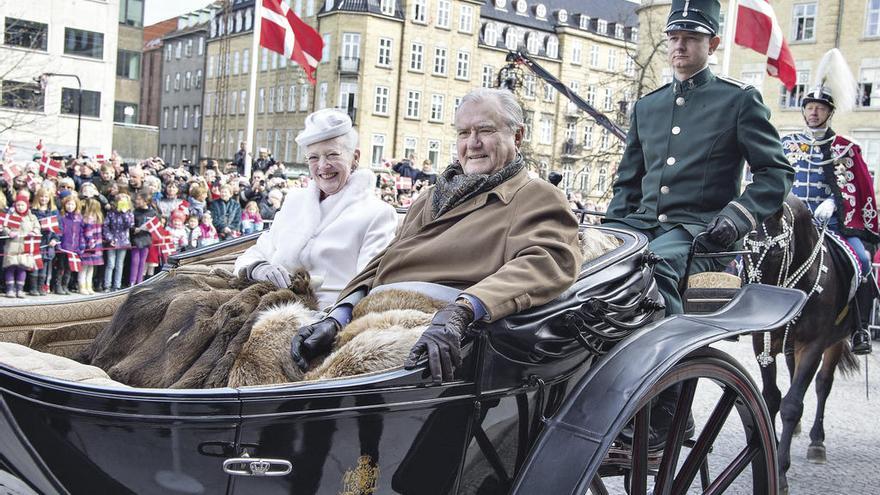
[0,229,804,495]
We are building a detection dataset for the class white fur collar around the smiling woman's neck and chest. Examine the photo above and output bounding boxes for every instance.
[272,169,376,270]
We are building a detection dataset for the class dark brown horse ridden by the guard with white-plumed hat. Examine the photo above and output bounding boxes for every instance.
[743,195,859,493]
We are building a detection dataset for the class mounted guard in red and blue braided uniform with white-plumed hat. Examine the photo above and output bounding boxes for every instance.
[782,48,880,354]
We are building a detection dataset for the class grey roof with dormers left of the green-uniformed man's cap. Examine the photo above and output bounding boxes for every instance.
[480,0,639,35]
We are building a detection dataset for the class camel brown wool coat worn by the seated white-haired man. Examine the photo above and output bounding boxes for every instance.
[339,168,583,321]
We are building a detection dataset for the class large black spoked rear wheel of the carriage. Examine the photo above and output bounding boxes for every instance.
[590,348,778,495]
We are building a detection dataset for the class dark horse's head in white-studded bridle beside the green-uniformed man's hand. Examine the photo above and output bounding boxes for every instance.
[743,194,817,285]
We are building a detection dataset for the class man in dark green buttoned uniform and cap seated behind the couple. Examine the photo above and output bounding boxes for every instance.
[603,0,793,447]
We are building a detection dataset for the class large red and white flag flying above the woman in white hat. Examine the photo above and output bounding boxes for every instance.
[260,0,324,84]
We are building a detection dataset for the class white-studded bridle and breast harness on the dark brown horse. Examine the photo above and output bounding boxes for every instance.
[743,203,828,367]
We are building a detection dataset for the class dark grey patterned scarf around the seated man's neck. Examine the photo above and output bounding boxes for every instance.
[431,152,525,220]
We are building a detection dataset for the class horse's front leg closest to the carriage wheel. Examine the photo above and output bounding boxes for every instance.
[779,341,824,489]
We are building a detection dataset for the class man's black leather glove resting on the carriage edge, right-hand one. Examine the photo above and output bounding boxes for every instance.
[403,303,474,383]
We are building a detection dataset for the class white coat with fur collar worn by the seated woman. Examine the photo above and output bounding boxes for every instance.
[235,169,397,308]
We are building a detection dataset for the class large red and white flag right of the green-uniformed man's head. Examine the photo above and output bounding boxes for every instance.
[735,0,797,91]
